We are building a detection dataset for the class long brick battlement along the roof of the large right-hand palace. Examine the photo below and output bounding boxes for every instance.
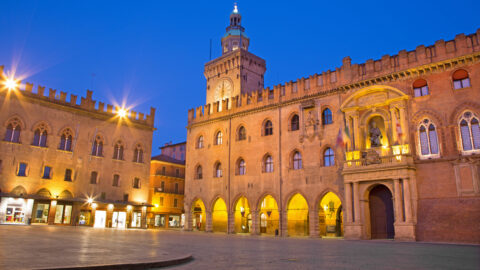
[188,29,480,125]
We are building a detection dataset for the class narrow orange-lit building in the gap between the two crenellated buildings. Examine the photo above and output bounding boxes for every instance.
[148,142,186,228]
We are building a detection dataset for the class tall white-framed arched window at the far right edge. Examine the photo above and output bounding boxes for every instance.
[459,112,480,152]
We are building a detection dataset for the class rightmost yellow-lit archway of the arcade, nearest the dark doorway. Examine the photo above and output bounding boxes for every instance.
[318,192,343,237]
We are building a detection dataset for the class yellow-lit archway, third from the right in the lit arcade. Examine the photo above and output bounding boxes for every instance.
[259,195,280,235]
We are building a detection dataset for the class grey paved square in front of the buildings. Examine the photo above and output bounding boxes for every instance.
[0,226,480,270]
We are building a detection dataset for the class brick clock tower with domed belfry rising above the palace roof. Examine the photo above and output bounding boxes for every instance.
[204,4,266,108]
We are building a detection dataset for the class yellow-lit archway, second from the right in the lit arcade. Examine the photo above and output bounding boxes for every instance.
[287,193,309,236]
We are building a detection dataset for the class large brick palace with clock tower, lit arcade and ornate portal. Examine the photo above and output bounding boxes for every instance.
[185,4,480,243]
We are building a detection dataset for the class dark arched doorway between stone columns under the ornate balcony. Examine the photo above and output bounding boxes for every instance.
[368,185,395,239]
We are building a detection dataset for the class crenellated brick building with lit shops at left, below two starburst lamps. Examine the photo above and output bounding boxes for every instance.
[0,66,155,228]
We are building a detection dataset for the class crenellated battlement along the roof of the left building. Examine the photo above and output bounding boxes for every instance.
[0,66,155,128]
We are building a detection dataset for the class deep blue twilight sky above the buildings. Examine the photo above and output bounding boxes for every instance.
[0,0,480,154]
